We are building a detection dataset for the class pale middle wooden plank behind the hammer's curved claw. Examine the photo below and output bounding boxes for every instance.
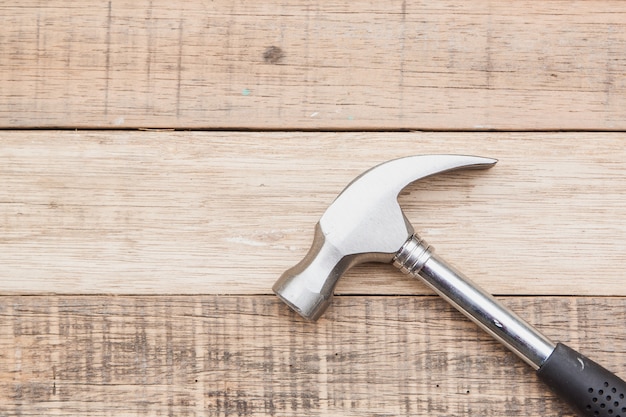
[0,131,626,295]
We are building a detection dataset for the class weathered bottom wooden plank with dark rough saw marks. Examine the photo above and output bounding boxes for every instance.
[0,296,626,417]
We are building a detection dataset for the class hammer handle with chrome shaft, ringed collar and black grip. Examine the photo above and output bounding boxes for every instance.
[393,234,626,417]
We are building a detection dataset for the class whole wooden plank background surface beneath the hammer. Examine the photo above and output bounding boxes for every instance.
[0,0,626,417]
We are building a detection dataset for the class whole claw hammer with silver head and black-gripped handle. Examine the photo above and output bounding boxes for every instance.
[273,155,626,417]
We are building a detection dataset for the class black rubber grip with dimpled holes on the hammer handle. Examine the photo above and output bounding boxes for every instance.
[537,343,626,417]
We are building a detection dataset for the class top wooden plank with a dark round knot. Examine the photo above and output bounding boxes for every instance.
[0,0,626,130]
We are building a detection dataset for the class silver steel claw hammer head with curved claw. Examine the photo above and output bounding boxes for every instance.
[273,155,497,320]
